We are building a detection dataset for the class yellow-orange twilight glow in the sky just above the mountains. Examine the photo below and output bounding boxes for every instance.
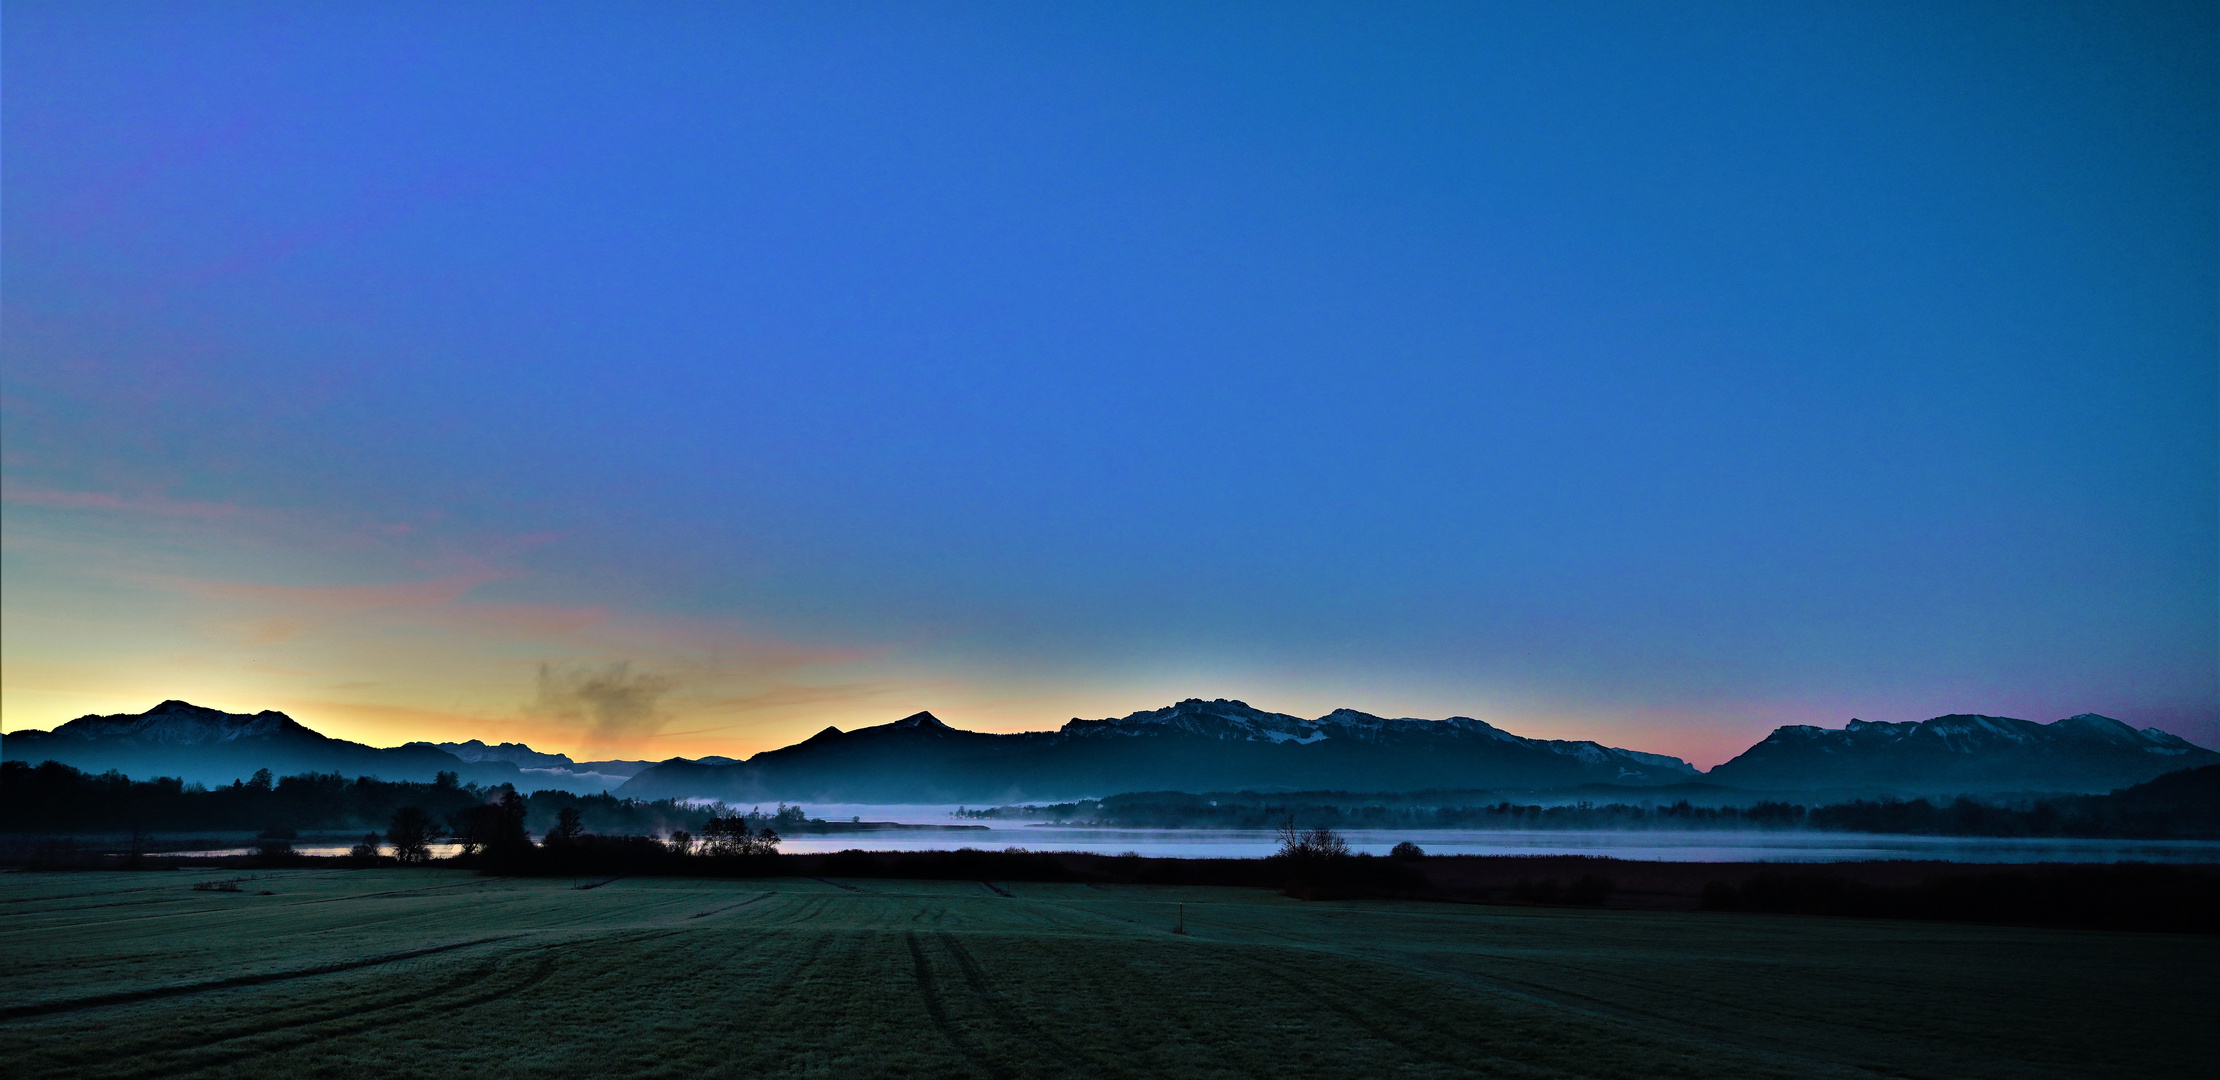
[0,491,2148,769]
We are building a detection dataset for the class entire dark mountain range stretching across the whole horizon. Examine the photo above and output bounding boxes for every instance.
[0,698,2220,802]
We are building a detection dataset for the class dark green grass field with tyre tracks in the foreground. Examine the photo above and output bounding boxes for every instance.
[0,869,2220,1080]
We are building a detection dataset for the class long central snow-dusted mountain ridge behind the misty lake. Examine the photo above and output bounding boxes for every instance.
[617,698,1696,802]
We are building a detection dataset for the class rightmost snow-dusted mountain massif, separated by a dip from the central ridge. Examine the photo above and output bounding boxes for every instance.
[1707,713,2220,793]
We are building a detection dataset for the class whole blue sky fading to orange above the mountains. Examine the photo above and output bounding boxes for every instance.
[0,0,2220,767]
